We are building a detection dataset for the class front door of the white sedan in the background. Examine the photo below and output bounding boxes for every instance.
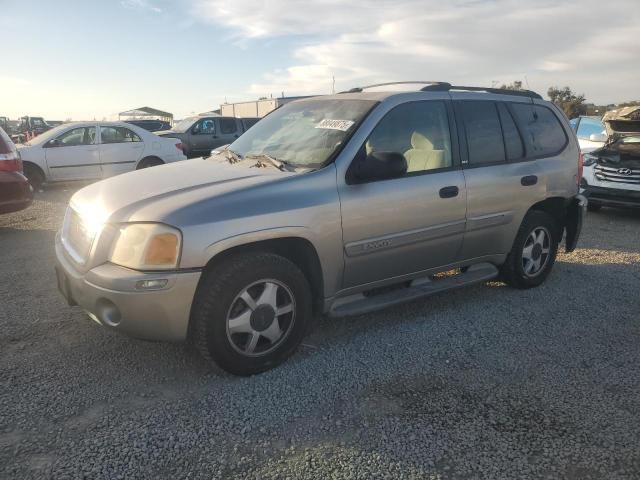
[43,125,102,181]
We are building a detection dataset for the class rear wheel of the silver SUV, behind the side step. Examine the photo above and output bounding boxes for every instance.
[500,210,561,289]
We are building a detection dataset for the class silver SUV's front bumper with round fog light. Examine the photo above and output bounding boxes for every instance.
[55,233,201,341]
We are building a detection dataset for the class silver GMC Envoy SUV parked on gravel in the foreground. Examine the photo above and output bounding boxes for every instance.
[56,82,586,375]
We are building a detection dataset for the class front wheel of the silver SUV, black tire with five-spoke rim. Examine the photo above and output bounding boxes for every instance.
[190,253,312,375]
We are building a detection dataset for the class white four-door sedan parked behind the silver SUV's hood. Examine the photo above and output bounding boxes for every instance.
[18,122,187,189]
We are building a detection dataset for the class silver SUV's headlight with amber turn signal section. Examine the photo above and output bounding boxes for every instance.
[109,223,182,270]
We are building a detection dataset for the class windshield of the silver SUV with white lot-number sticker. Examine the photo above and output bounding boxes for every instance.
[229,99,375,168]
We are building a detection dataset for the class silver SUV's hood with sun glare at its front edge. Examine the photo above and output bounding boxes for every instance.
[70,158,296,226]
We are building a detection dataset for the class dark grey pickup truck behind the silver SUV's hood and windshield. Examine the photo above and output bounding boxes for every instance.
[155,116,260,158]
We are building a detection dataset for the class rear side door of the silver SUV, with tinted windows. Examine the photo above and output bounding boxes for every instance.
[454,100,546,259]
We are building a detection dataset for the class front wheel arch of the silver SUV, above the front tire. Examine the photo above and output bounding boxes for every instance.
[203,236,324,312]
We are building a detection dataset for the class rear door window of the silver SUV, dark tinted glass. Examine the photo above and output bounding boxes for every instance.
[459,100,505,165]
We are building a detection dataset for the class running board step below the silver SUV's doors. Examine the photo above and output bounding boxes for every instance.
[329,263,499,317]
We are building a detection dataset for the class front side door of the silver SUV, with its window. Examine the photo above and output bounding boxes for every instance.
[339,100,466,287]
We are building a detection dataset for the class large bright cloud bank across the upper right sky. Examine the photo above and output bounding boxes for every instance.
[193,0,640,99]
